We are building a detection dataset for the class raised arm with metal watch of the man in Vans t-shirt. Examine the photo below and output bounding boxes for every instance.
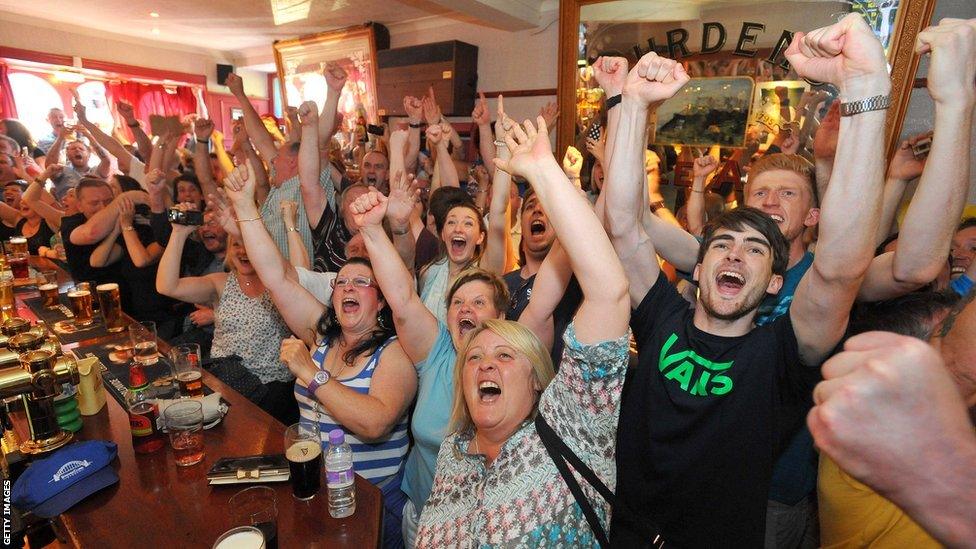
[786,14,891,365]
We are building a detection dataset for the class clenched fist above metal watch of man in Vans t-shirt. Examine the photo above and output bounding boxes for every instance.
[785,13,891,94]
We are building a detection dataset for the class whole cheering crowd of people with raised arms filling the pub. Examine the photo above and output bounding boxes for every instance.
[0,15,976,547]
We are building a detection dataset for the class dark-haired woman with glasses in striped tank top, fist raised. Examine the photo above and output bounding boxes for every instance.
[224,161,417,547]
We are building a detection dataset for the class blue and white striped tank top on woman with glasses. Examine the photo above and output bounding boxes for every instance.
[295,336,409,484]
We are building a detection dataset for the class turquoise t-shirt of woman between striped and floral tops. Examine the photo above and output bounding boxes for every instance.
[401,322,457,512]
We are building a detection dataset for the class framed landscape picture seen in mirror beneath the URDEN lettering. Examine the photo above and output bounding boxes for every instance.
[651,76,754,147]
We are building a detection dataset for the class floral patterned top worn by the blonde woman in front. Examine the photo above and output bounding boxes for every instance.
[417,322,630,547]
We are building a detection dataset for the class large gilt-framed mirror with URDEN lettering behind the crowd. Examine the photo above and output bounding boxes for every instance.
[557,0,936,191]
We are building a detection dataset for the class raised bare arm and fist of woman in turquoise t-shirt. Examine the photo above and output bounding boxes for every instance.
[350,191,438,364]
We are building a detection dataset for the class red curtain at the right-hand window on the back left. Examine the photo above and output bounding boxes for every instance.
[105,82,197,143]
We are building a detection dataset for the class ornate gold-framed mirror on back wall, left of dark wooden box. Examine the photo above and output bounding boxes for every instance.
[274,24,386,135]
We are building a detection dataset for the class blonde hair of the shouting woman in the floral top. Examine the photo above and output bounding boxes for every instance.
[450,318,556,432]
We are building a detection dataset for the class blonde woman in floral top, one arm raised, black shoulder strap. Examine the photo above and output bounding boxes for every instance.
[417,117,630,547]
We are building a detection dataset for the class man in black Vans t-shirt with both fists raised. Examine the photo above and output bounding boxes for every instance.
[594,16,890,547]
